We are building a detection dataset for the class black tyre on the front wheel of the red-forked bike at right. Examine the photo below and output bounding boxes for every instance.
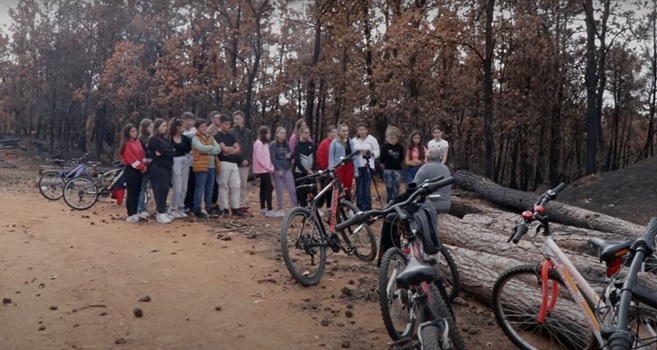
[492,265,597,350]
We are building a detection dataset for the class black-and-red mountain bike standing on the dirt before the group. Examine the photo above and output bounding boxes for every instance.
[281,152,377,287]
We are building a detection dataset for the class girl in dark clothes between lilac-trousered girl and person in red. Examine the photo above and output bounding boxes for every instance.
[294,126,317,207]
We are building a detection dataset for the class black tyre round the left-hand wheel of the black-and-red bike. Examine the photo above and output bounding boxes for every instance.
[281,207,326,287]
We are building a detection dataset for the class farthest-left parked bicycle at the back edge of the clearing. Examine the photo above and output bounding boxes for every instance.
[38,153,93,201]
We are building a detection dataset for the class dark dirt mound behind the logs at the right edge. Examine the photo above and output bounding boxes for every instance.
[559,158,657,225]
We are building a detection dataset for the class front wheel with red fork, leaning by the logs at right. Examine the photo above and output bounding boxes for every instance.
[492,265,597,350]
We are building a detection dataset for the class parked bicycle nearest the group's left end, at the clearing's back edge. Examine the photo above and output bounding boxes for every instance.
[64,163,124,210]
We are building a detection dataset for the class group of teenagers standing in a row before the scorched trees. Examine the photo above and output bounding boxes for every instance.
[119,111,449,224]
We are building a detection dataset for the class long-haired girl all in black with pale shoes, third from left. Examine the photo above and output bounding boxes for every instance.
[148,118,176,224]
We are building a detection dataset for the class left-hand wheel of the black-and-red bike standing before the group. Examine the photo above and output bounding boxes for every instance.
[281,207,326,287]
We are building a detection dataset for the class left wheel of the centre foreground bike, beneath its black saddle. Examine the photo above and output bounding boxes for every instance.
[379,248,415,341]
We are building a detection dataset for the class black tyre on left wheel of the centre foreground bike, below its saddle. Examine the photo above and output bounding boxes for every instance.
[379,247,415,341]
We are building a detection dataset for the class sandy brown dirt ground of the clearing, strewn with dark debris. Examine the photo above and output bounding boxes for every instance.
[0,154,512,350]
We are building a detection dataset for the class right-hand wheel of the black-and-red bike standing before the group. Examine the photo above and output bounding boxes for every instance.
[337,199,376,262]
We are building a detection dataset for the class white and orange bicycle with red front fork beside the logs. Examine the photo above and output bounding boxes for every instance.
[492,183,657,350]
